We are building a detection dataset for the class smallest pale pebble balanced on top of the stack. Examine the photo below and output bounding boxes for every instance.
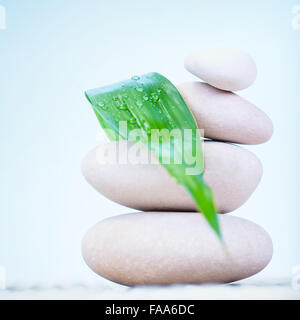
[185,49,257,91]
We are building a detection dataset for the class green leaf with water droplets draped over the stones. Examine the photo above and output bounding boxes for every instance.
[85,73,221,239]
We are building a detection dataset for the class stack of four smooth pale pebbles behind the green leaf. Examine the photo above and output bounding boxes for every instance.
[83,49,273,285]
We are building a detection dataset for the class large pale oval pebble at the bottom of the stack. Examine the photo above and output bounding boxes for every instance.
[82,212,272,286]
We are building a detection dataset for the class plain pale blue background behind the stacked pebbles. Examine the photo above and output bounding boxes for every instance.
[0,0,300,286]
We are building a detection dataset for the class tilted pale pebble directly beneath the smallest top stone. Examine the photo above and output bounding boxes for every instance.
[177,82,273,144]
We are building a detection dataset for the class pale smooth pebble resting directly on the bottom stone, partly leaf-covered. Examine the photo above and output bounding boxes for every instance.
[82,141,262,213]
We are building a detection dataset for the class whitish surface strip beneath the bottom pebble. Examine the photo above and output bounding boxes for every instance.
[0,280,300,300]
